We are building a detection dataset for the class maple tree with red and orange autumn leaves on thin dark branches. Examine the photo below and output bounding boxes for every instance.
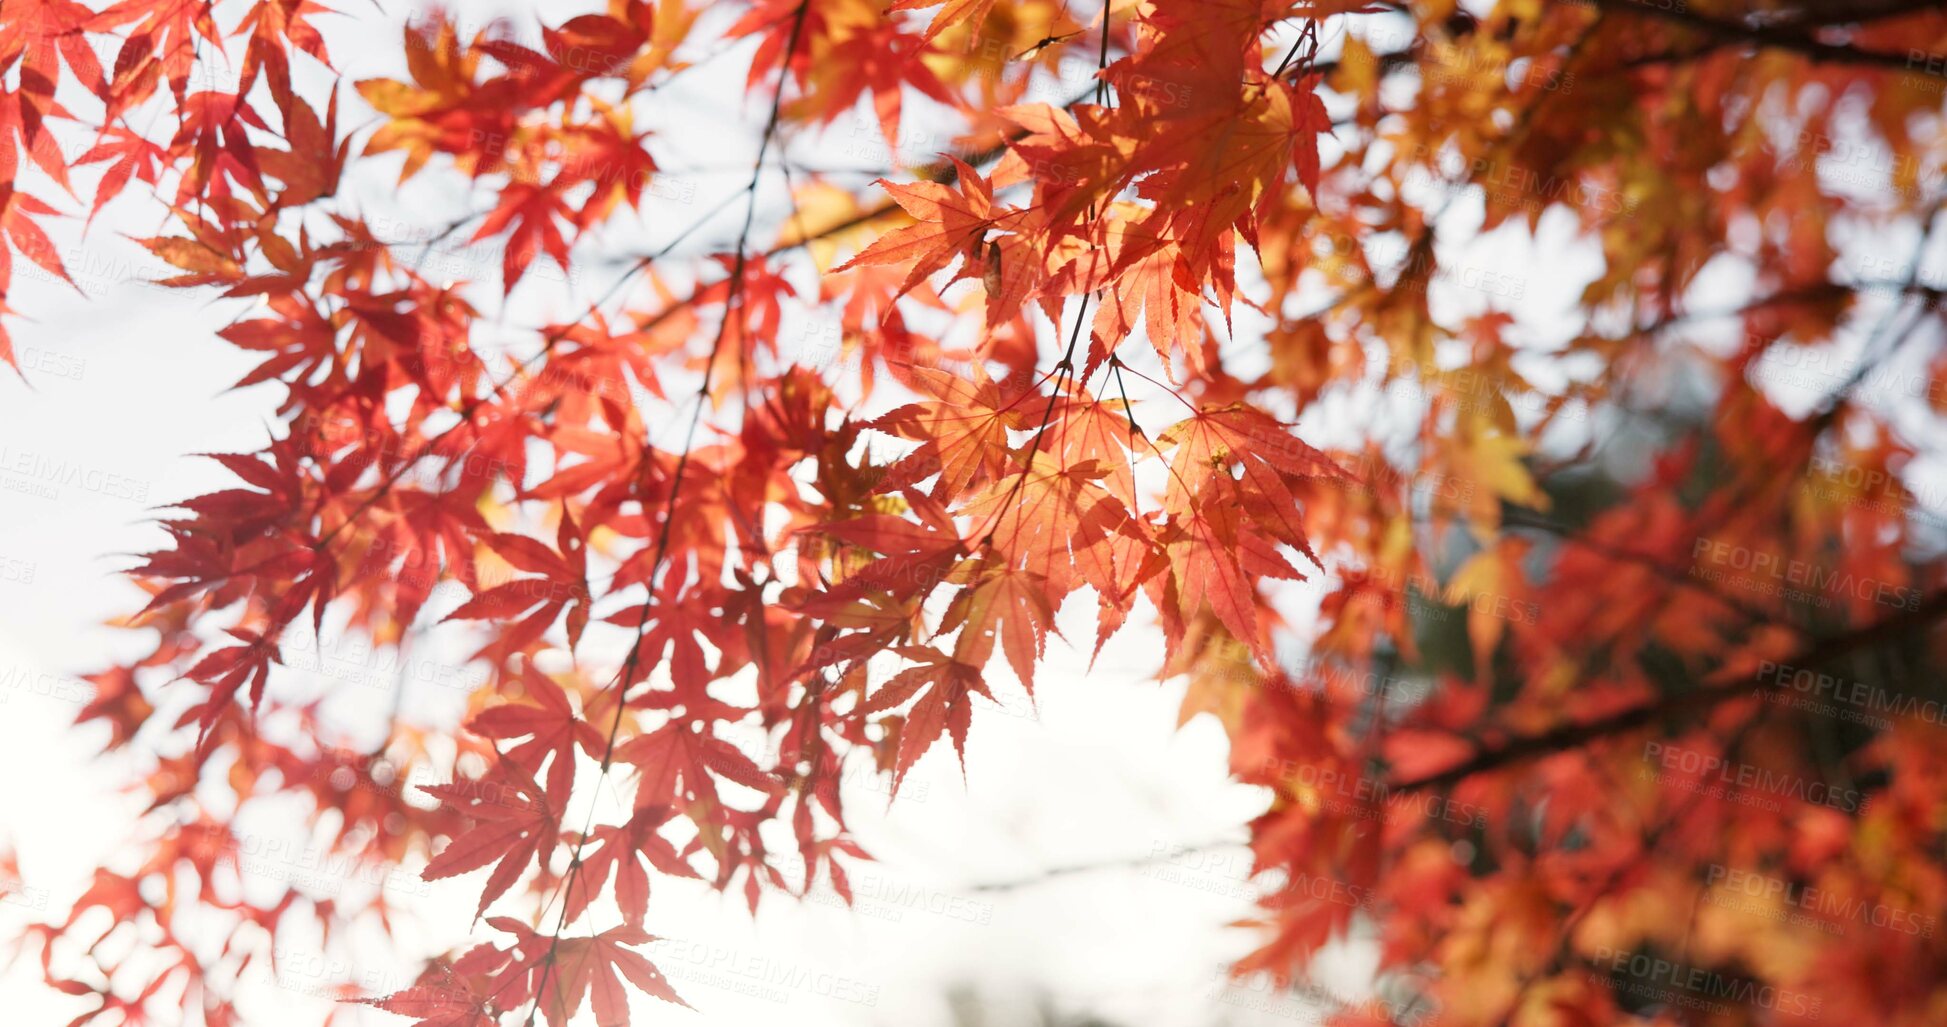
[0,0,1947,1027]
